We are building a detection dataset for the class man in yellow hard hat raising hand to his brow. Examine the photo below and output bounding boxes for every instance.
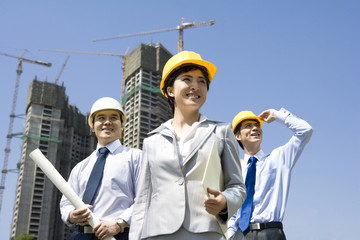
[228,108,313,240]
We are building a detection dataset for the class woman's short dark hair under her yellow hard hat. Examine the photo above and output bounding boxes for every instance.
[162,63,210,114]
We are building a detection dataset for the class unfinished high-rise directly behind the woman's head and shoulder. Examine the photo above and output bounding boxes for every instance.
[122,43,172,149]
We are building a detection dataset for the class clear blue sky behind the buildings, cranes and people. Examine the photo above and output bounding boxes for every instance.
[0,0,360,240]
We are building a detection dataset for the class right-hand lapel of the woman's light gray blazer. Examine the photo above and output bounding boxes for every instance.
[183,122,215,166]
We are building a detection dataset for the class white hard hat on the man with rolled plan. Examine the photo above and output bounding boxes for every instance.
[88,97,126,128]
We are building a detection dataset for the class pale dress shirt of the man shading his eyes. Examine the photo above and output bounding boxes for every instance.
[227,108,313,238]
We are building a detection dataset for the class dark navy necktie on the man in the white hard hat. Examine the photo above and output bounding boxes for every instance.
[82,147,109,205]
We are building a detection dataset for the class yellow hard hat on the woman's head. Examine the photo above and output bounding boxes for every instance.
[160,51,217,97]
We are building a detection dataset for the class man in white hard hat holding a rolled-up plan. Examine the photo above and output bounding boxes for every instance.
[60,97,141,240]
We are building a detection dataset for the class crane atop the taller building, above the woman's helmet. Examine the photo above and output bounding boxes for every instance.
[93,18,215,52]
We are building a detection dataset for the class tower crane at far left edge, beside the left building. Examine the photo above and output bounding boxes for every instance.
[0,52,51,212]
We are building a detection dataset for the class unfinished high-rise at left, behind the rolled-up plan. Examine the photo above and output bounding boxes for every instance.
[11,79,96,240]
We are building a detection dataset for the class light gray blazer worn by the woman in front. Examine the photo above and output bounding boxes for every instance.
[130,120,246,239]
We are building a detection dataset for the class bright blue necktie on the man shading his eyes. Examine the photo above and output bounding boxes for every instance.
[239,157,256,232]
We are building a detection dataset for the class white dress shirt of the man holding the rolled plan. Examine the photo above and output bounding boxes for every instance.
[60,140,141,225]
